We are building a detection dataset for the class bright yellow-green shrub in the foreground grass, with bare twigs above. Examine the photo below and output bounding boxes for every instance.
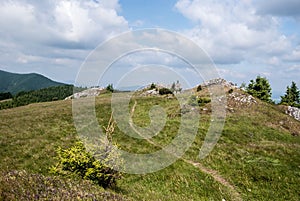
[50,115,121,188]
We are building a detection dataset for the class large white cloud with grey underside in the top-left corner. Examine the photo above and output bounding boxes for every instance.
[0,0,128,48]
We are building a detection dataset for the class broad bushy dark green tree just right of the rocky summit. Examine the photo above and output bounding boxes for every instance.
[246,76,272,102]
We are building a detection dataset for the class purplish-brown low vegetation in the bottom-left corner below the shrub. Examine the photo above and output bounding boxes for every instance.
[0,170,125,201]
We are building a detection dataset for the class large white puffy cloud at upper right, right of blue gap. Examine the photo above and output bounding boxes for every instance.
[175,0,291,64]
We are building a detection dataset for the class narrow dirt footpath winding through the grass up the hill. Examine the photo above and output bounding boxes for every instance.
[130,101,243,201]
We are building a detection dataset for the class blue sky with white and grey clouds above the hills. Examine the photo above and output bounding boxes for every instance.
[0,0,300,99]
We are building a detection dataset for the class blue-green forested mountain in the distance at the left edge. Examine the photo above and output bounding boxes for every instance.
[0,70,65,94]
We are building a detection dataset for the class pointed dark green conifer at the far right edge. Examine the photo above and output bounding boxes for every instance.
[280,81,300,107]
